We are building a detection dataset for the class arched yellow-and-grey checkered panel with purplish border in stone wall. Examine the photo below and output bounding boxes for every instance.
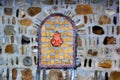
[38,13,76,68]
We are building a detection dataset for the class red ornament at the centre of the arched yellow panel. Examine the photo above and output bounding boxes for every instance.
[51,31,63,47]
